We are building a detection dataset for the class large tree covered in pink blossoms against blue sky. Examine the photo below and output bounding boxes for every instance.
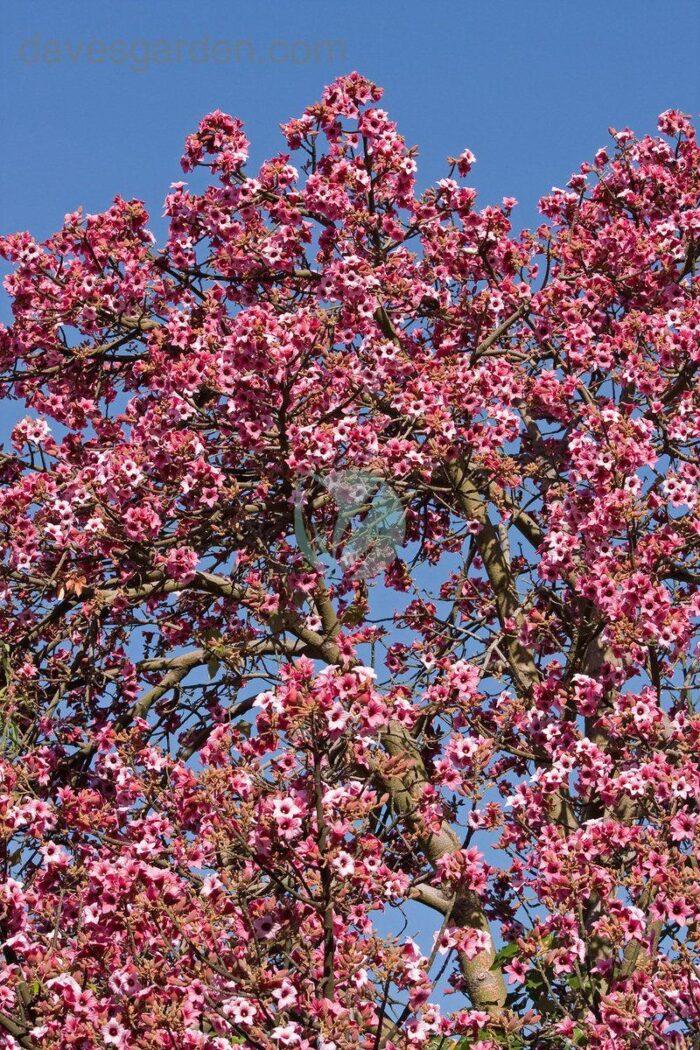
[0,74,700,1050]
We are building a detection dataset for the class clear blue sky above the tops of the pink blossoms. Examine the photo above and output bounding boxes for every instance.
[0,0,700,248]
